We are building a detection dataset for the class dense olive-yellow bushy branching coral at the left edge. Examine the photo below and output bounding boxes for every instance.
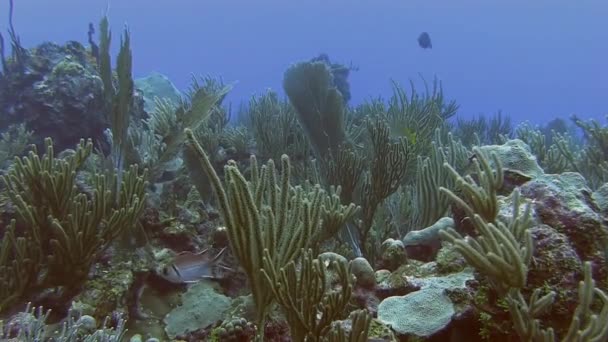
[0,139,145,310]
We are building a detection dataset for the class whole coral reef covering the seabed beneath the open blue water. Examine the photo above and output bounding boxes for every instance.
[0,5,608,342]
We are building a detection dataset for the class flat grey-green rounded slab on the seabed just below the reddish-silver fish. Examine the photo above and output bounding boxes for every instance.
[164,281,230,338]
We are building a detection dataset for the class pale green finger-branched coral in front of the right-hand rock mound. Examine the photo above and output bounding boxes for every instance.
[439,148,533,294]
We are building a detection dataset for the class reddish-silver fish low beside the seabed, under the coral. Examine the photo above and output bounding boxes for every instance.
[159,247,233,284]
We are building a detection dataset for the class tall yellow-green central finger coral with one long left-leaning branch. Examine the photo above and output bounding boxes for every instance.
[186,130,356,336]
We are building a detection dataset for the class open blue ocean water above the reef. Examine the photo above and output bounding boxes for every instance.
[0,0,608,123]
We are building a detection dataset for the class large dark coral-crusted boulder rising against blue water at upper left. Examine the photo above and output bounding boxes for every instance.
[0,41,107,151]
